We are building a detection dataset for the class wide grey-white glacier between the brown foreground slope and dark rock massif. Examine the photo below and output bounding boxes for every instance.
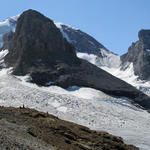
[0,52,150,150]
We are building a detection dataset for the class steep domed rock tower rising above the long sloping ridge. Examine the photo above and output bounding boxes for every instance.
[5,10,78,74]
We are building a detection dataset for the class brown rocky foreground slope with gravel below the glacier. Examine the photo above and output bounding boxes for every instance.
[0,107,138,150]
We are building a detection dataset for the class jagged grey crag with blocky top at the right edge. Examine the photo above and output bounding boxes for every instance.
[121,30,150,80]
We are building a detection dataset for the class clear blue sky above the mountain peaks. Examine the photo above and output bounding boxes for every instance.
[0,0,150,54]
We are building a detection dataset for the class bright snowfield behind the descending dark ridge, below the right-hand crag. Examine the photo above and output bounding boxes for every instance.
[77,53,150,96]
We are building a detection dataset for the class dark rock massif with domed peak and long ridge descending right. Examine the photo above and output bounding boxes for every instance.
[5,10,150,109]
